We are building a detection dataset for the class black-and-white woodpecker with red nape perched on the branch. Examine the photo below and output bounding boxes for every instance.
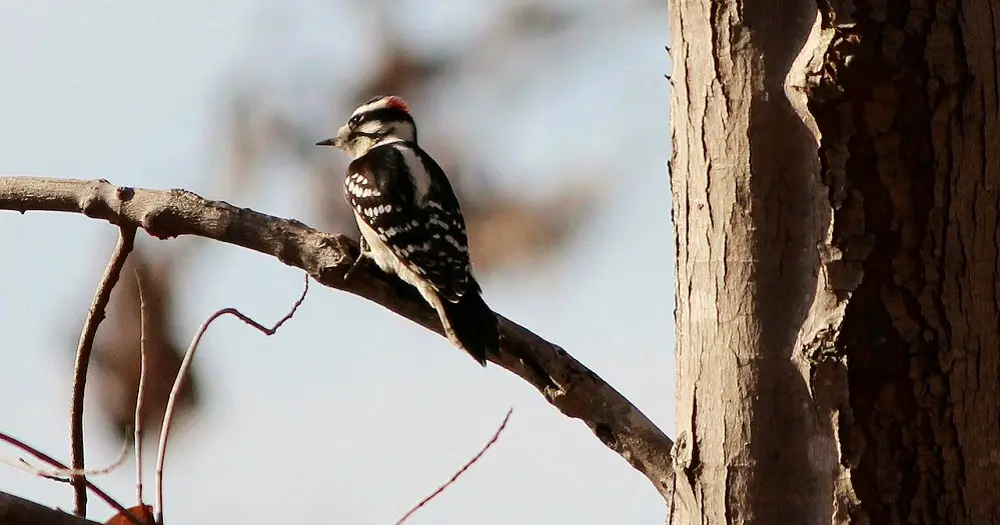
[316,95,500,366]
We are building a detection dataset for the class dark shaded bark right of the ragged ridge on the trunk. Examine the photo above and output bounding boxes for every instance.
[812,0,1000,524]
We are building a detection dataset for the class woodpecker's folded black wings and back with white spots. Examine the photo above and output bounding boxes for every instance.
[344,142,479,302]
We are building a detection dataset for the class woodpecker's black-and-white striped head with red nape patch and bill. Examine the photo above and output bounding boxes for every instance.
[316,95,417,158]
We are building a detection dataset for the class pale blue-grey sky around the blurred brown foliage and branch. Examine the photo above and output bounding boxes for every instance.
[0,0,675,525]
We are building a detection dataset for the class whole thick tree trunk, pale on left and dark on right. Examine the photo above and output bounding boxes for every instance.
[670,0,1000,524]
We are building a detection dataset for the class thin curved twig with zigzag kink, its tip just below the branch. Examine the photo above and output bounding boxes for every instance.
[154,274,309,523]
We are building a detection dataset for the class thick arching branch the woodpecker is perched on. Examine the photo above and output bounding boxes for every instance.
[0,177,674,496]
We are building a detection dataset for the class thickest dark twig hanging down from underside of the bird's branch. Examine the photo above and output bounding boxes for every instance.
[69,226,135,518]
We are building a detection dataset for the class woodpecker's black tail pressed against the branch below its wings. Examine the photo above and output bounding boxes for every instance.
[438,290,500,366]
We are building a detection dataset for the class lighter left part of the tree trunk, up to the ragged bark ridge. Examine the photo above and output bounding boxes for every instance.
[671,0,836,524]
